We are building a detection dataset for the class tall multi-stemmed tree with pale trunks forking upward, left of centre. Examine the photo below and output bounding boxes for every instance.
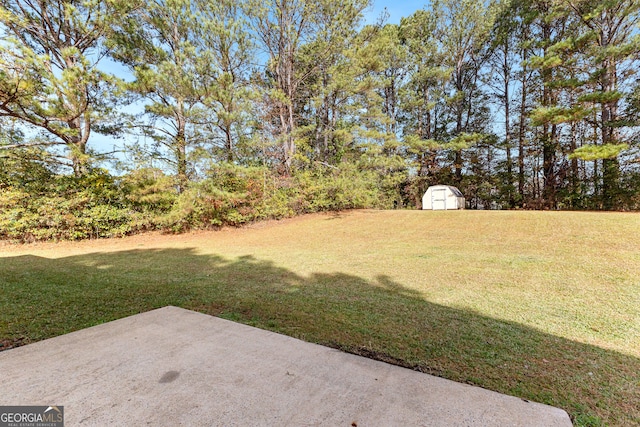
[247,0,369,172]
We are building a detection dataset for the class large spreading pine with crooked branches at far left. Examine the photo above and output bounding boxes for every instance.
[0,0,130,175]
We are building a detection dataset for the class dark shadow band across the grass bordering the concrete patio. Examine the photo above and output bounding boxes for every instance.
[0,249,640,425]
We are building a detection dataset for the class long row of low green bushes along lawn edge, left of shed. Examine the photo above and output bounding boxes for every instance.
[0,164,402,242]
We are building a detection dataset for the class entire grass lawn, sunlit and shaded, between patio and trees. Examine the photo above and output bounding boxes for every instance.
[0,211,640,425]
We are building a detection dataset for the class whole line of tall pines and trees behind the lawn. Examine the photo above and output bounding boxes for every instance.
[0,0,640,241]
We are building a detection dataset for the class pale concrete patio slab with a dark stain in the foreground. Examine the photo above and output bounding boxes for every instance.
[0,307,571,427]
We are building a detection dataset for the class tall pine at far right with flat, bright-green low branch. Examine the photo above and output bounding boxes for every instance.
[567,0,640,209]
